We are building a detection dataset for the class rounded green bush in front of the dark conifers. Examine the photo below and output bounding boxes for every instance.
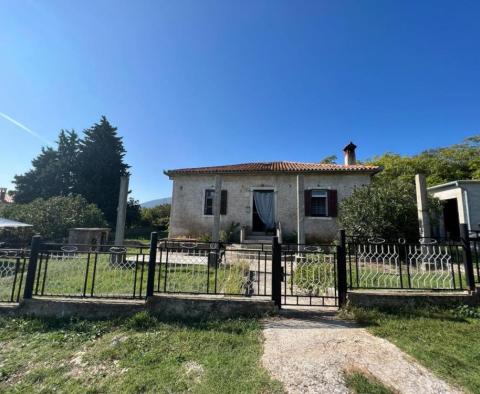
[0,196,107,241]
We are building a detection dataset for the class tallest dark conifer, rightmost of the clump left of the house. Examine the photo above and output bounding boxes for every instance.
[75,116,129,226]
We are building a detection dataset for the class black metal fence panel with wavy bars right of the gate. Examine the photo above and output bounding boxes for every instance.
[347,238,468,290]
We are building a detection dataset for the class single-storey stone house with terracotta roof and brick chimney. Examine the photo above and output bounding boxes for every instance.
[165,143,381,243]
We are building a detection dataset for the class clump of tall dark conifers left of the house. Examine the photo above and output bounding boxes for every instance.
[14,116,129,226]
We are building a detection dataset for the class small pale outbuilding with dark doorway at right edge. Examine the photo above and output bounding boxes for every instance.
[427,180,480,239]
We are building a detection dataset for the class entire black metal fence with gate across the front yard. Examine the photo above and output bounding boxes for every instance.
[4,228,480,306]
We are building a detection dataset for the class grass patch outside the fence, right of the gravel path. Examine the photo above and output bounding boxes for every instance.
[349,306,480,393]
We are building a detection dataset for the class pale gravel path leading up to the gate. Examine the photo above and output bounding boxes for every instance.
[262,313,460,394]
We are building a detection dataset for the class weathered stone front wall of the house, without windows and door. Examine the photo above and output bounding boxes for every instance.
[169,172,372,241]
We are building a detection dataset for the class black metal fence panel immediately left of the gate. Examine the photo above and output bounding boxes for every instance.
[155,241,272,296]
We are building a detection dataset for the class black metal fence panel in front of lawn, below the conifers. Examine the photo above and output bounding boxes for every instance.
[32,244,149,298]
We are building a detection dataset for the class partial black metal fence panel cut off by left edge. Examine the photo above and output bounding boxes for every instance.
[0,248,29,302]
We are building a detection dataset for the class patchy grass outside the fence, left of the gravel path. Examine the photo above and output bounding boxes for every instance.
[0,313,283,393]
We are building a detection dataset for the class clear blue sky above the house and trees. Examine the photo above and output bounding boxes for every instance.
[0,0,480,201]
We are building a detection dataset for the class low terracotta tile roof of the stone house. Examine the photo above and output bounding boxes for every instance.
[165,161,381,177]
